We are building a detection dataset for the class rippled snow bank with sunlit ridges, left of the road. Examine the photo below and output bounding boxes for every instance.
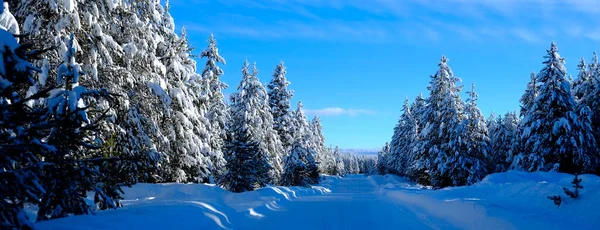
[34,183,330,230]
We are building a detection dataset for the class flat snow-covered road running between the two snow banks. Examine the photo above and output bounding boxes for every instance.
[241,175,439,229]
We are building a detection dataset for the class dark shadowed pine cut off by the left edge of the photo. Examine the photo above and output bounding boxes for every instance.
[0,22,46,229]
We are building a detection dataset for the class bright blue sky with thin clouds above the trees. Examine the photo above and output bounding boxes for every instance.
[170,0,600,149]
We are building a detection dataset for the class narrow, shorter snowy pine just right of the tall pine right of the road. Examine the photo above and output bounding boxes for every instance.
[446,84,490,186]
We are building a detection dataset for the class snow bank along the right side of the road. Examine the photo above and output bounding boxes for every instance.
[383,171,600,230]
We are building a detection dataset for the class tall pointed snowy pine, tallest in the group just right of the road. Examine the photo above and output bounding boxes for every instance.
[410,56,465,188]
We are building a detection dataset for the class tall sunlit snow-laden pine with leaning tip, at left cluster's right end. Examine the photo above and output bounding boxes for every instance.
[157,5,214,183]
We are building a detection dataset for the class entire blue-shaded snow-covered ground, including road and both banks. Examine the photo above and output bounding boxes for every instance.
[37,171,600,230]
